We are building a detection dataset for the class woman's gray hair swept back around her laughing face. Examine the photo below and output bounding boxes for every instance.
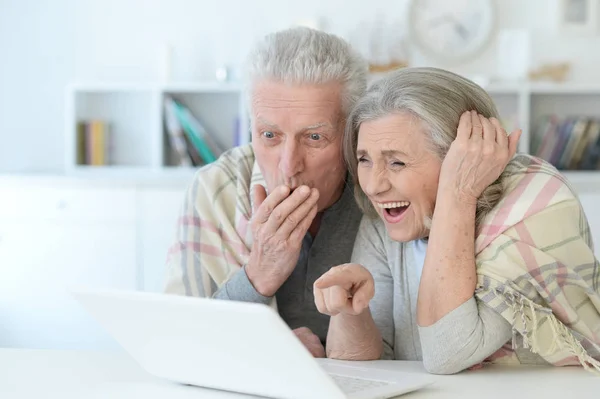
[343,67,519,233]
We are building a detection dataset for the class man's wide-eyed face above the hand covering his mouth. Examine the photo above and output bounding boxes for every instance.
[252,81,346,211]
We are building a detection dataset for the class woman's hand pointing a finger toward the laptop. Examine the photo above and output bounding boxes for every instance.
[313,263,375,316]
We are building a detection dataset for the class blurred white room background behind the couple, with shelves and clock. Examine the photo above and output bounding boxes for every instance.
[0,0,600,354]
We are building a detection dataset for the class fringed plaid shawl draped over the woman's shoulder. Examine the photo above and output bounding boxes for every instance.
[475,155,600,372]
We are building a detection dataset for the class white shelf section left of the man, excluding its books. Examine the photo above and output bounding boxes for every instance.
[65,82,250,176]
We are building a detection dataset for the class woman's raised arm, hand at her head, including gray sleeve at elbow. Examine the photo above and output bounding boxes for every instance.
[417,113,519,374]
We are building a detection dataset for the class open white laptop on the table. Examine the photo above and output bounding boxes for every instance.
[72,290,432,399]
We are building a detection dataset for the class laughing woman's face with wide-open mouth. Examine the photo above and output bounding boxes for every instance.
[357,114,442,242]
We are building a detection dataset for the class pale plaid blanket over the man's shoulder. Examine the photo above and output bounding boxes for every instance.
[164,145,265,297]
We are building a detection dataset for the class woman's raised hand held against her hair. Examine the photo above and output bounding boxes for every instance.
[439,111,521,204]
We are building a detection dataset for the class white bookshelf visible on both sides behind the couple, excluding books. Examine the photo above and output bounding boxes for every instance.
[65,82,600,190]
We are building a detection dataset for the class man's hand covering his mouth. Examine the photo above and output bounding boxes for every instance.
[246,186,319,297]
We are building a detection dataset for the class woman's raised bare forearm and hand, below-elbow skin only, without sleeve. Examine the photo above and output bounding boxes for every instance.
[417,111,520,327]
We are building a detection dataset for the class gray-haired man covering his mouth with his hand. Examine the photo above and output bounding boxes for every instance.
[165,28,367,356]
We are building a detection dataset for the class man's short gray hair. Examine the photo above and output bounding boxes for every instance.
[246,27,368,117]
